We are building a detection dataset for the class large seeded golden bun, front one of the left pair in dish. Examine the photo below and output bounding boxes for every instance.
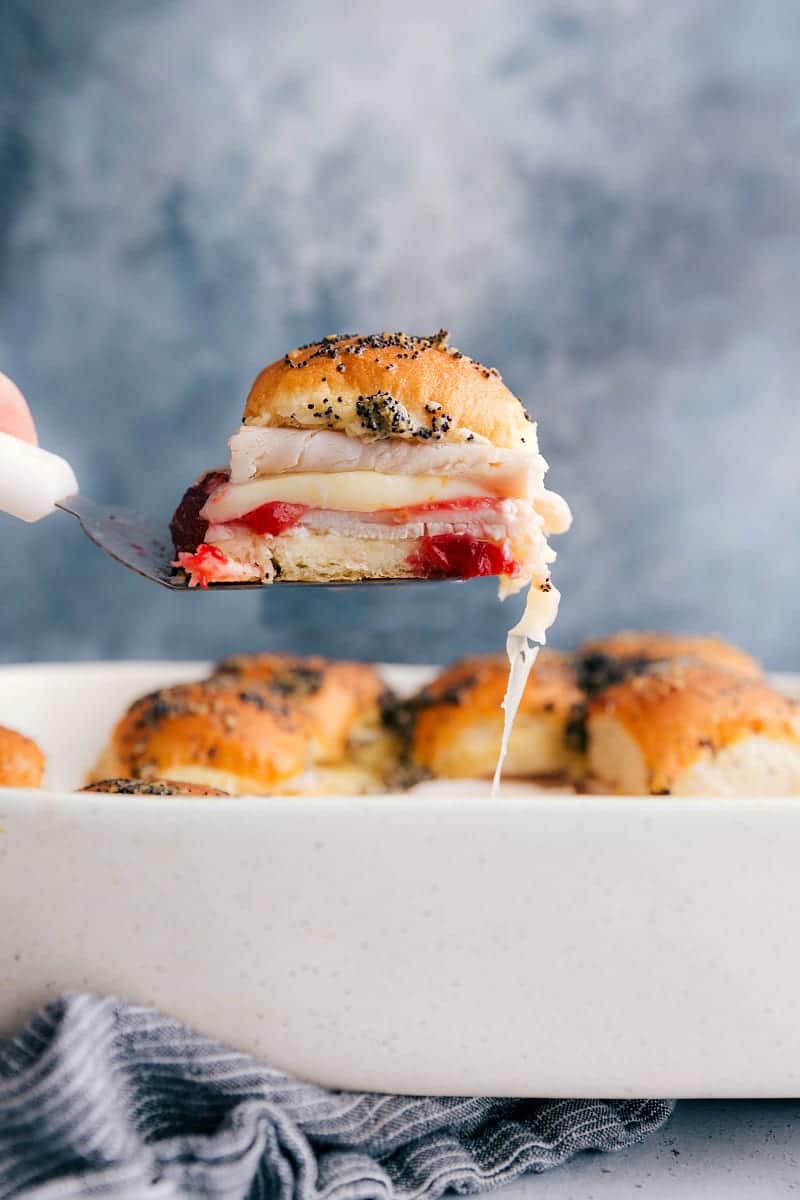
[89,679,308,796]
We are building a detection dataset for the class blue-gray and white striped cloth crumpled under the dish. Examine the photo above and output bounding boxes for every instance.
[0,995,672,1200]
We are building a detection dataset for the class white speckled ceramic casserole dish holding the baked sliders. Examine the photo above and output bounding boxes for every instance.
[0,662,800,1097]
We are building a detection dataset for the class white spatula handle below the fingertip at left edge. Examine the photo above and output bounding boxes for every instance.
[0,433,78,521]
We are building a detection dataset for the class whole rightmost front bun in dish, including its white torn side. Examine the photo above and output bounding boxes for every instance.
[588,662,800,796]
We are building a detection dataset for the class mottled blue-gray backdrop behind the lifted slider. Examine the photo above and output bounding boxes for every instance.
[0,0,800,667]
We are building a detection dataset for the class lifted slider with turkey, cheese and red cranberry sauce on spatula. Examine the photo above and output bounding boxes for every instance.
[170,331,571,624]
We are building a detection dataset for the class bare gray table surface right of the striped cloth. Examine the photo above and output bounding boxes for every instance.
[499,1100,800,1200]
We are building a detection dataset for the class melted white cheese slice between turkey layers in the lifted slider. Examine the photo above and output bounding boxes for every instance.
[203,470,486,524]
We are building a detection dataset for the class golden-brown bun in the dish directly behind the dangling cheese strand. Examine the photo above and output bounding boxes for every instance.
[411,649,584,779]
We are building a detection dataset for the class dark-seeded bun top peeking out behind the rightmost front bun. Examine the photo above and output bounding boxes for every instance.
[578,630,763,695]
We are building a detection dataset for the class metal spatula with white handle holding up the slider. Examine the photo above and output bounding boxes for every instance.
[0,433,419,592]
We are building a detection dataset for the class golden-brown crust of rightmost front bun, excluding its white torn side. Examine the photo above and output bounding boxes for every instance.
[589,661,800,794]
